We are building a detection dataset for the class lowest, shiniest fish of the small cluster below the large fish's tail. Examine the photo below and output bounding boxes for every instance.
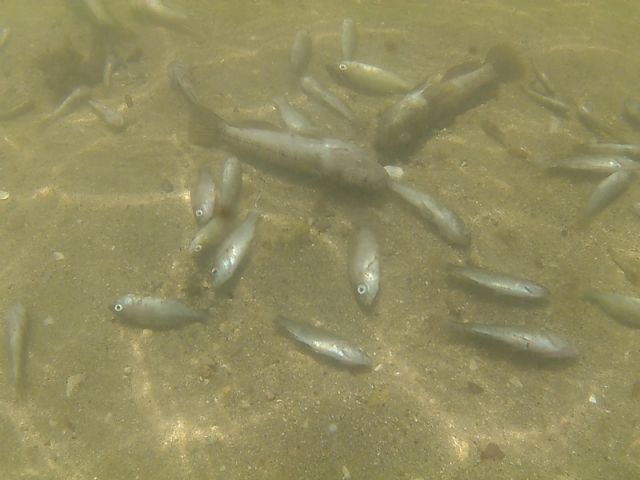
[211,210,260,288]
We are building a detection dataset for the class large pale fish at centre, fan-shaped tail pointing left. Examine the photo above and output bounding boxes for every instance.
[185,106,387,190]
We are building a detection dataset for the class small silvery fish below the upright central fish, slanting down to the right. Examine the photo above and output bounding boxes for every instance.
[276,316,371,367]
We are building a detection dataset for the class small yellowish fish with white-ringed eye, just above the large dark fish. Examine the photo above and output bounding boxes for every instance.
[326,60,413,95]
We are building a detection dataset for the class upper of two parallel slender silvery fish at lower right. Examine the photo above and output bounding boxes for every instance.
[448,265,549,300]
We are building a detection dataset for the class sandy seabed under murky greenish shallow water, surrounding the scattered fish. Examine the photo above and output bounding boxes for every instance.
[0,0,640,480]
